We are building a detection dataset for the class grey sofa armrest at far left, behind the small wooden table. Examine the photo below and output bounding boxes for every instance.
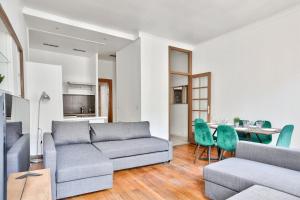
[7,134,30,175]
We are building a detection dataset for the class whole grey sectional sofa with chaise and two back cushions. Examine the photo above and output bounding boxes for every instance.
[43,121,173,199]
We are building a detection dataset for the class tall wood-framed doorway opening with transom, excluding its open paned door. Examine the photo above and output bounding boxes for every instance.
[169,47,192,145]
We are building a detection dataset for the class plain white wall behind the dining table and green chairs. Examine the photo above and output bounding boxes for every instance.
[193,7,300,147]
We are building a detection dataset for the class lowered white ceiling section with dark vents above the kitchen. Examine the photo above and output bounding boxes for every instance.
[25,14,132,58]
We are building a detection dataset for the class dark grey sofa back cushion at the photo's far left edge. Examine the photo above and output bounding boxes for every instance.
[6,122,22,149]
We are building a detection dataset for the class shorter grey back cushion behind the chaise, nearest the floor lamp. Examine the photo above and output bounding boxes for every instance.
[52,121,91,145]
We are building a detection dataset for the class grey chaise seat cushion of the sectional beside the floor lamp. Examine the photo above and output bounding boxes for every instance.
[56,144,113,183]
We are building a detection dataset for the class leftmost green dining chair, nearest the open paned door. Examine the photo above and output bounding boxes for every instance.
[194,119,216,163]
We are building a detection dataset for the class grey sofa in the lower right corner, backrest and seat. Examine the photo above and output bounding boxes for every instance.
[203,142,300,200]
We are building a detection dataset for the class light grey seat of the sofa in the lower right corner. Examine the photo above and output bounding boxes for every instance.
[204,158,300,197]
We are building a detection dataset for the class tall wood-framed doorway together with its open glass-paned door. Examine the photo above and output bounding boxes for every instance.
[169,47,211,145]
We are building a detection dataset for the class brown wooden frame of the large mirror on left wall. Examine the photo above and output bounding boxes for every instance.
[0,4,25,97]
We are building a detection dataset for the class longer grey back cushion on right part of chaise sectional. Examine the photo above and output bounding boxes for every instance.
[91,122,151,142]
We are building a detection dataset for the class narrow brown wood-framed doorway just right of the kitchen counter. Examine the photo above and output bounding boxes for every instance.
[98,78,113,123]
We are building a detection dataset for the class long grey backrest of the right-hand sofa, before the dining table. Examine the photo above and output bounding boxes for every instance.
[236,142,300,171]
